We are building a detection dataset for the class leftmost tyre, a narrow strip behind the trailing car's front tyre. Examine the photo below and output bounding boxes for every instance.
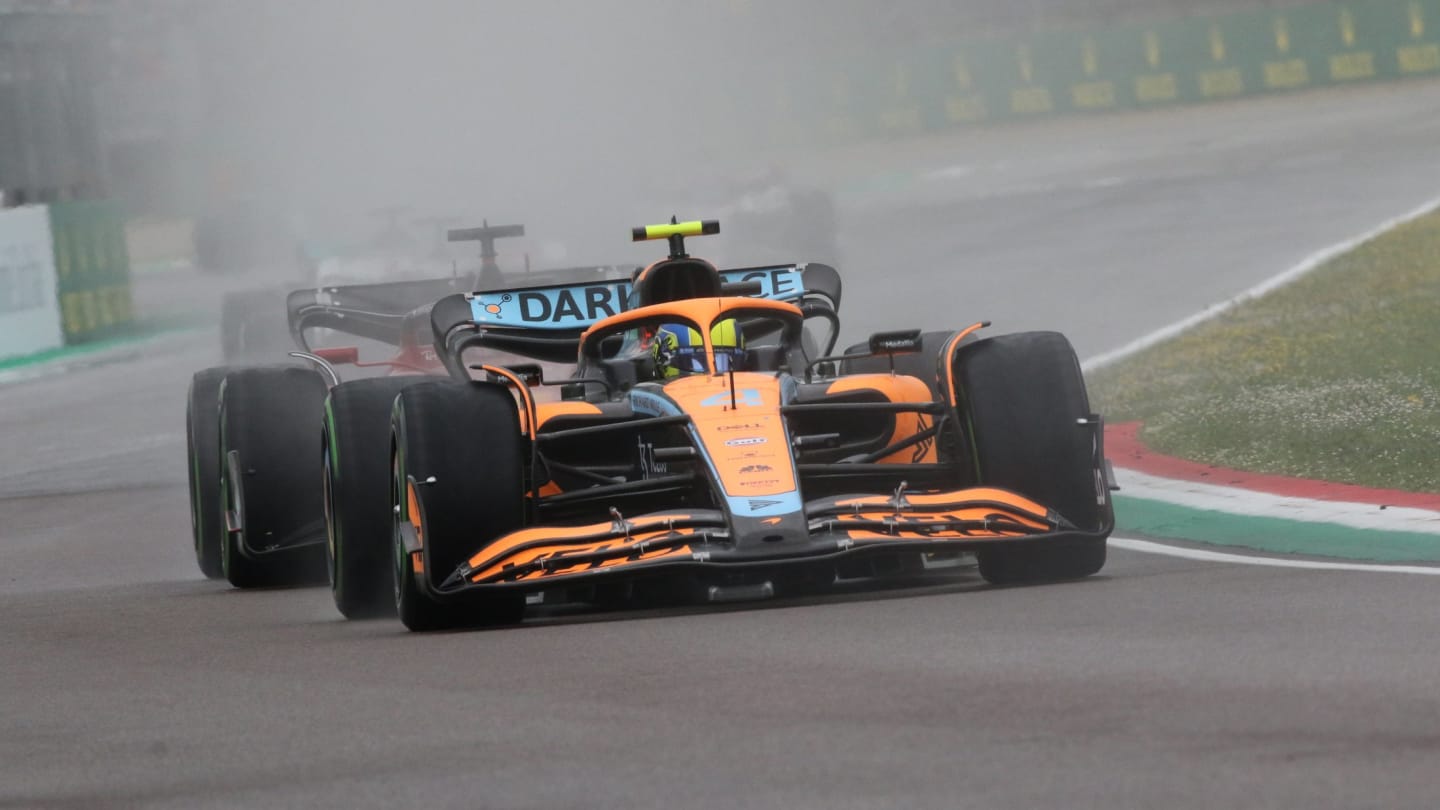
[184,368,230,579]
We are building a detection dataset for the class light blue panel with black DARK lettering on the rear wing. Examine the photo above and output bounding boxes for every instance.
[469,265,805,330]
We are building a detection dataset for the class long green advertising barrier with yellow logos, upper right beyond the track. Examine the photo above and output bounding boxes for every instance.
[768,0,1440,144]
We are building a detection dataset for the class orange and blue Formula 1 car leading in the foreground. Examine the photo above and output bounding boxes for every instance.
[341,222,1113,630]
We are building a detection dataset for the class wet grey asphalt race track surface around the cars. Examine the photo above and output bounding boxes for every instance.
[8,84,1440,809]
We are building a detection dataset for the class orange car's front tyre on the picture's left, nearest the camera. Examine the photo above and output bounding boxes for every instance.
[390,380,527,631]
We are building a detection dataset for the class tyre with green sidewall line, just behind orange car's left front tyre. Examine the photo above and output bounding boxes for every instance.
[323,376,436,618]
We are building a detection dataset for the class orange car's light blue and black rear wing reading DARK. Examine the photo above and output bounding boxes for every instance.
[431,264,841,379]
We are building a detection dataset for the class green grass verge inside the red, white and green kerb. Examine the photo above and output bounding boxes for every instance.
[1087,206,1440,491]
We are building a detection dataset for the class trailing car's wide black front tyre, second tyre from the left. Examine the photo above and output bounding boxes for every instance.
[219,366,325,588]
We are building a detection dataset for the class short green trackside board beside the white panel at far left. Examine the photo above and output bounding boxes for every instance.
[49,200,134,344]
